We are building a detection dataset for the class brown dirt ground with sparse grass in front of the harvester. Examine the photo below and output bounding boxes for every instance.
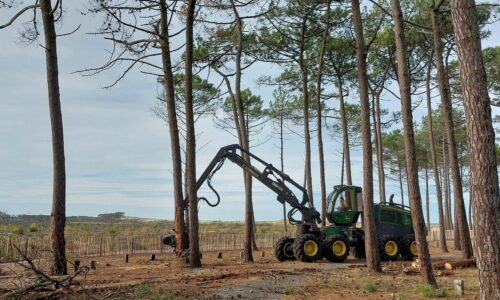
[0,247,479,300]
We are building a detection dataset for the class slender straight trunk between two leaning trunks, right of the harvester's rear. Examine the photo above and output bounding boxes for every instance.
[425,55,448,252]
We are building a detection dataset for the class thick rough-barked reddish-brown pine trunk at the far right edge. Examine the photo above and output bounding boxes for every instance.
[451,0,500,300]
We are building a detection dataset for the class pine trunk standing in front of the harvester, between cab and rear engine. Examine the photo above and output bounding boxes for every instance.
[352,0,381,272]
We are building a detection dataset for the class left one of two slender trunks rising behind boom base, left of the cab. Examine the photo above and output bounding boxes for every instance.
[299,17,314,206]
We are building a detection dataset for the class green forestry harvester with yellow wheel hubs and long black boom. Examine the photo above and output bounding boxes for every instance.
[163,144,417,262]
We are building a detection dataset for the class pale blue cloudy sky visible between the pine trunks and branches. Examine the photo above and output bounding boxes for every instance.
[0,2,500,222]
